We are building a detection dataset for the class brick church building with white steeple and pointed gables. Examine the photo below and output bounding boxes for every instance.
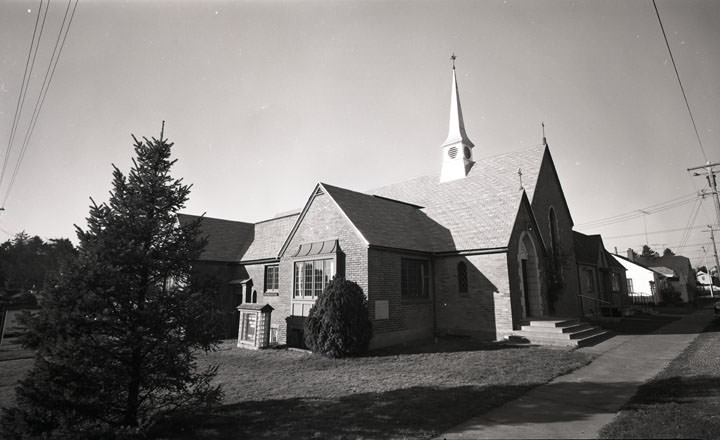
[179,63,580,347]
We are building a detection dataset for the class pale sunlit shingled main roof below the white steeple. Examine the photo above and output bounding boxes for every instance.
[370,146,545,251]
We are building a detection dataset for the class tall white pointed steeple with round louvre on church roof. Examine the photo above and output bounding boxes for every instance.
[440,54,475,182]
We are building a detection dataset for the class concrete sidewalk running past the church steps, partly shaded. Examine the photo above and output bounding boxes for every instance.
[438,308,713,440]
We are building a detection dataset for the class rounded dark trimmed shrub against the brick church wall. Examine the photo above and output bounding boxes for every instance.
[305,277,373,358]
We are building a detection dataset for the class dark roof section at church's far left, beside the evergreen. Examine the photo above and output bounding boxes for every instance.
[177,214,254,262]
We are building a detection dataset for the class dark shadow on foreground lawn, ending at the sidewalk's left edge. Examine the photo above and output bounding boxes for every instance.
[156,385,532,439]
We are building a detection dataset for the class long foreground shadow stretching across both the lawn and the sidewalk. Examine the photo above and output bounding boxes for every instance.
[149,378,720,439]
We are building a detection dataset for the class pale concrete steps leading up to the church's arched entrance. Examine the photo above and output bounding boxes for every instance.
[513,319,613,347]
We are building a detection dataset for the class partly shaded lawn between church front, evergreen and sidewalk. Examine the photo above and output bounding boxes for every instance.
[159,338,590,439]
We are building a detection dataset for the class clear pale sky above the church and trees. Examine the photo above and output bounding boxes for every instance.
[0,0,720,265]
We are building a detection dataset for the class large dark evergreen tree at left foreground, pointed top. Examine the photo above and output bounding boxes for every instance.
[2,130,220,438]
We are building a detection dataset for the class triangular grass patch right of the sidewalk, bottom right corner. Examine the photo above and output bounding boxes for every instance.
[600,319,720,439]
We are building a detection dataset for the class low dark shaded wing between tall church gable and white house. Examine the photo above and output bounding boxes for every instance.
[573,232,627,317]
